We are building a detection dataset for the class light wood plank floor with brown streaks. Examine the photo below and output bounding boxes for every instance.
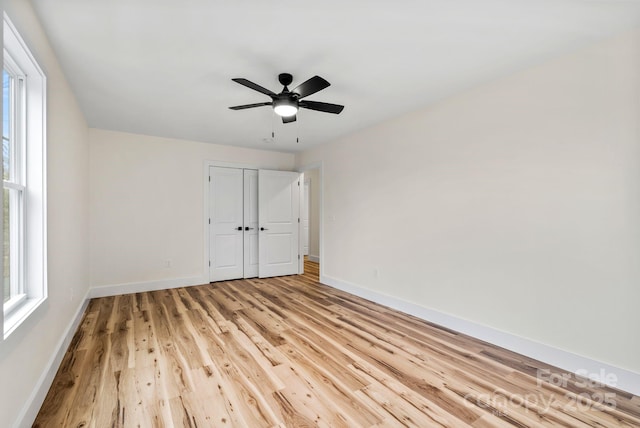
[35,263,640,427]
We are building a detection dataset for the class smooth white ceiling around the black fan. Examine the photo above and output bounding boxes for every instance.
[32,0,640,151]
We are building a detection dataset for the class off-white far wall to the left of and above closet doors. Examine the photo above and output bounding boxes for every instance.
[90,129,295,292]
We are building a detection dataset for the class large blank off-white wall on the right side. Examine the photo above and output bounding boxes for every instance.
[297,31,640,373]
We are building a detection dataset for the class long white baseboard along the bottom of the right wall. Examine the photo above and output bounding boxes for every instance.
[320,275,640,395]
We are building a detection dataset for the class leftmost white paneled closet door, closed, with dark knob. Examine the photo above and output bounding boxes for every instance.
[209,167,244,281]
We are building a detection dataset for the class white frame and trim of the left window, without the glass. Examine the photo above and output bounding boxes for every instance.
[0,13,47,339]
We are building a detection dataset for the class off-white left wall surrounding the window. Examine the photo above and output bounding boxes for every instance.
[0,0,89,427]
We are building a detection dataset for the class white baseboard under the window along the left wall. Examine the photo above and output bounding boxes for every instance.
[14,291,89,428]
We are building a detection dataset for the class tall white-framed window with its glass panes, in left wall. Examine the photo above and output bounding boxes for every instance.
[2,13,47,338]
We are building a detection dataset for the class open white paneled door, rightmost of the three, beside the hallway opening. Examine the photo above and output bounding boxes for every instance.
[258,170,300,278]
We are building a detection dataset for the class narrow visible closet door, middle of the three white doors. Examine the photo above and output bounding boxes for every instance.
[244,169,259,278]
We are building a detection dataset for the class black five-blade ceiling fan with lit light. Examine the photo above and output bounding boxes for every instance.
[229,73,344,123]
